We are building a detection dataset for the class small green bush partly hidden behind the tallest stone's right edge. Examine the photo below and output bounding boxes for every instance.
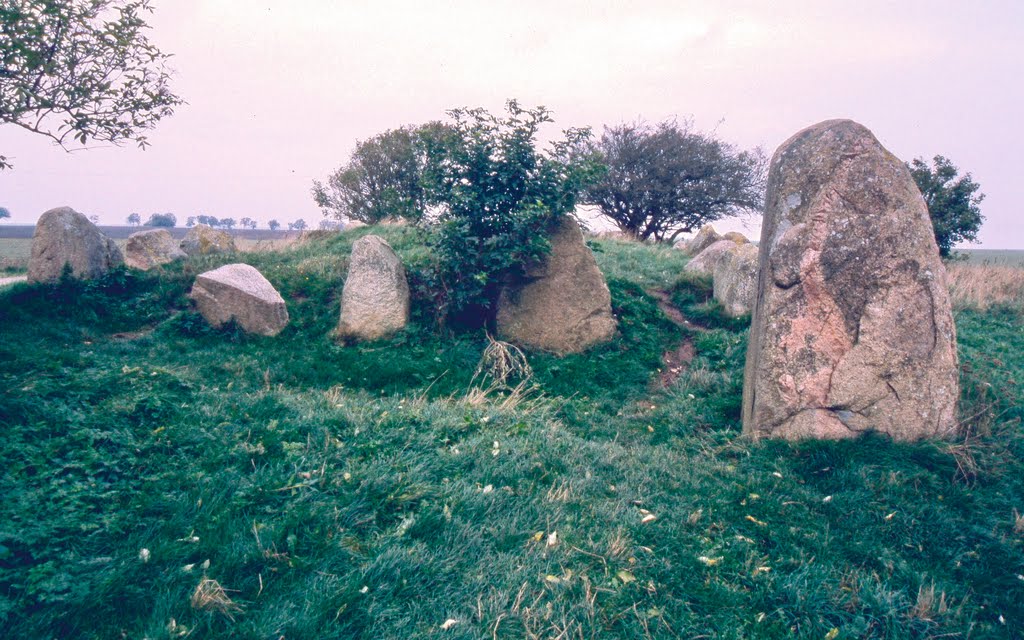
[907,156,985,257]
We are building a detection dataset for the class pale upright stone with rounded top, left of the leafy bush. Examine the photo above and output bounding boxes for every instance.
[338,236,409,340]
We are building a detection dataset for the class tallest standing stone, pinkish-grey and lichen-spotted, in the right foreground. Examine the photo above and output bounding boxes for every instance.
[743,120,958,440]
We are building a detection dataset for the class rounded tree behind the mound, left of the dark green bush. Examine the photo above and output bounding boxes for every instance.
[312,122,451,224]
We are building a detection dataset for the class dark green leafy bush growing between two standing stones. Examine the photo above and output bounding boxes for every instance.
[423,100,596,325]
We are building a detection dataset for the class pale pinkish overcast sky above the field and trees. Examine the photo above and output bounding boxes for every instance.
[0,0,1024,249]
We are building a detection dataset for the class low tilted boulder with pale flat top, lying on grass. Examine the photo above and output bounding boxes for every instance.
[189,263,288,336]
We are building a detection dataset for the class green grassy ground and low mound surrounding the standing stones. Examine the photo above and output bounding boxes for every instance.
[0,227,1024,639]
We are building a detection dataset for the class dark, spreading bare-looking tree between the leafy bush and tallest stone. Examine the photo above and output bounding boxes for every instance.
[584,120,766,242]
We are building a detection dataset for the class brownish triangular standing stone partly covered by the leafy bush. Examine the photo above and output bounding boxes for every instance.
[497,217,616,353]
